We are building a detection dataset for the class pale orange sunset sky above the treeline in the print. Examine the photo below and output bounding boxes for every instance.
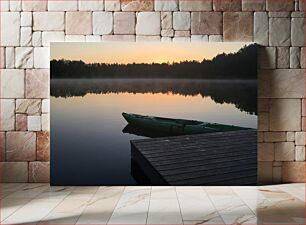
[51,42,249,64]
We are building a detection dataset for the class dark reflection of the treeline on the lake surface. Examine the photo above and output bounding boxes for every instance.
[51,79,257,114]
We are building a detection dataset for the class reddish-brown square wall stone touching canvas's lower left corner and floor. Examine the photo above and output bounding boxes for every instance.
[29,162,50,183]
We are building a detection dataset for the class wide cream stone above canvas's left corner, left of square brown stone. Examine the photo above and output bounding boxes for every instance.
[33,12,65,31]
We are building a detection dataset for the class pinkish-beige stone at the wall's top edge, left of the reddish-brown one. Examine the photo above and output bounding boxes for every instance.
[179,0,212,11]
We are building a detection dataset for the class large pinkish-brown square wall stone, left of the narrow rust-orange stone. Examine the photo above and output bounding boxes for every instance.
[6,132,36,161]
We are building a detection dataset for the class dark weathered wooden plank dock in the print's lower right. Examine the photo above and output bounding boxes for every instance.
[131,130,257,186]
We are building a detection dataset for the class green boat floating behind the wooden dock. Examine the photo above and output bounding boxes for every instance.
[122,113,249,135]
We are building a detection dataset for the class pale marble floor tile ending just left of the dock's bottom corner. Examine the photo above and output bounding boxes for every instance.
[108,187,151,224]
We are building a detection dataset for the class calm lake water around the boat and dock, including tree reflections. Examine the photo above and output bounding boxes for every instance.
[51,79,257,185]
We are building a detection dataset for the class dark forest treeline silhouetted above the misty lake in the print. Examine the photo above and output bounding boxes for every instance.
[51,44,257,80]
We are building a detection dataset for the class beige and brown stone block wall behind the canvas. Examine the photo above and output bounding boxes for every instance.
[0,0,306,183]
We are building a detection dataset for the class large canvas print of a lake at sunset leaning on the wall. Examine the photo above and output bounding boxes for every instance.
[51,42,257,186]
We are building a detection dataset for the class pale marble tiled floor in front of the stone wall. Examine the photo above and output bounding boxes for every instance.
[1,184,306,224]
